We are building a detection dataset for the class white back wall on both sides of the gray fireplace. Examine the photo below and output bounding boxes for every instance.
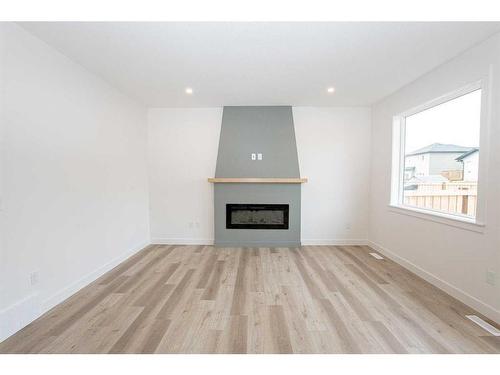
[148,107,370,244]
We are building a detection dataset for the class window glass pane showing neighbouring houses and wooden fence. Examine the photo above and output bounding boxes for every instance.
[403,90,481,217]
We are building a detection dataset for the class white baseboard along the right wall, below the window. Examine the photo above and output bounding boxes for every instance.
[368,241,500,324]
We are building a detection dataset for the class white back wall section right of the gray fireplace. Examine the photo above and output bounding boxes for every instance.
[293,107,371,245]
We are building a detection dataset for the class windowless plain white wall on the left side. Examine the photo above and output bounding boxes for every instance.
[0,23,149,340]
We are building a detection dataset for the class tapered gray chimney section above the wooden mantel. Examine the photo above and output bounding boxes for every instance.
[215,107,300,177]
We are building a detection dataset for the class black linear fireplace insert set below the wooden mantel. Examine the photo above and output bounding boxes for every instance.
[226,204,289,229]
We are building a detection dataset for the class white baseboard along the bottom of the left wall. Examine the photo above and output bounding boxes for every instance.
[0,242,149,342]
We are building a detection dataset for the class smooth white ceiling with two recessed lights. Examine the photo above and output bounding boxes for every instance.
[21,22,500,107]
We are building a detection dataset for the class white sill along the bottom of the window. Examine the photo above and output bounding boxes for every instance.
[389,204,485,233]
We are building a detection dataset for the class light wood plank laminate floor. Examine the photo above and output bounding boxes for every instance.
[0,245,500,353]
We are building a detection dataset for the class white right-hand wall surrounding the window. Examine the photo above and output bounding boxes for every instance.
[369,35,500,322]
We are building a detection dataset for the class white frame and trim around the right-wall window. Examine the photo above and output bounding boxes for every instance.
[389,77,491,232]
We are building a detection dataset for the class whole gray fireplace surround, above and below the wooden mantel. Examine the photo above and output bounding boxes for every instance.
[214,106,301,247]
